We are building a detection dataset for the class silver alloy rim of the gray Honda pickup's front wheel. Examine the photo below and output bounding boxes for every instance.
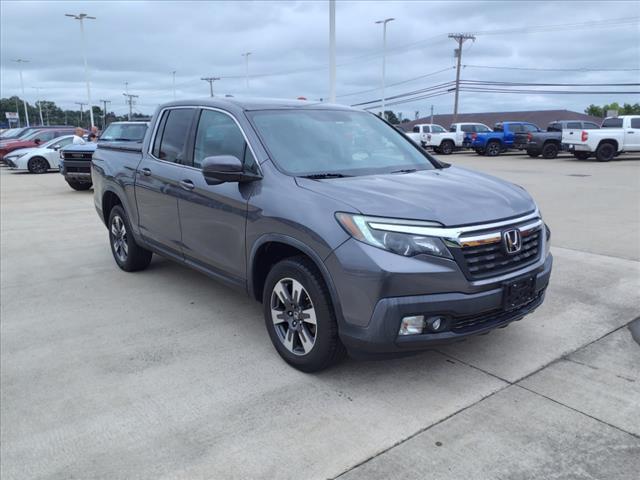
[271,278,318,355]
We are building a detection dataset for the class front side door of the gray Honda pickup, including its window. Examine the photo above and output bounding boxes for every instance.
[178,108,259,285]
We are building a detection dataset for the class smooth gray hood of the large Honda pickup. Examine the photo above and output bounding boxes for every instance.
[296,166,536,227]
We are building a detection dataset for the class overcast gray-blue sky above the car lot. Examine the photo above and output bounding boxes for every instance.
[0,0,640,119]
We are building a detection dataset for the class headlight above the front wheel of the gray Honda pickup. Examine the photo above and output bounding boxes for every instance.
[336,213,453,258]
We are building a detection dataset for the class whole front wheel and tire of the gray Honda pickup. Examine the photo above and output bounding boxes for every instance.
[262,256,346,373]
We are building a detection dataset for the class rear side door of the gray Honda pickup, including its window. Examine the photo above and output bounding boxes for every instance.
[135,108,196,257]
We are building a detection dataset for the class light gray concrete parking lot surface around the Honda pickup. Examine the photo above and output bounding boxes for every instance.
[0,153,640,480]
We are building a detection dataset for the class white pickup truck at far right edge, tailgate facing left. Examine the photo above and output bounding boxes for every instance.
[562,115,640,162]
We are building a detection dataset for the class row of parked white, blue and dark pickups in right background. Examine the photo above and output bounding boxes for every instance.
[405,115,640,161]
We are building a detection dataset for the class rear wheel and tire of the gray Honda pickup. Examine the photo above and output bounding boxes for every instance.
[108,205,153,272]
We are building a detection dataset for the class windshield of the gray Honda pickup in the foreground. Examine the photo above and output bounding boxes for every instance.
[248,110,435,176]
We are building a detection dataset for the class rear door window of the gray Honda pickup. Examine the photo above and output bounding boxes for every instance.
[152,108,195,163]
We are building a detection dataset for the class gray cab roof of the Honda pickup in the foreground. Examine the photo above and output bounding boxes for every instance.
[156,97,356,110]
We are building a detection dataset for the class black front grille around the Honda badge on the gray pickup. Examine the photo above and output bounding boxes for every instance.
[452,220,543,280]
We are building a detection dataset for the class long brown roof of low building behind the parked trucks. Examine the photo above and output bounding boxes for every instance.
[401,110,603,131]
